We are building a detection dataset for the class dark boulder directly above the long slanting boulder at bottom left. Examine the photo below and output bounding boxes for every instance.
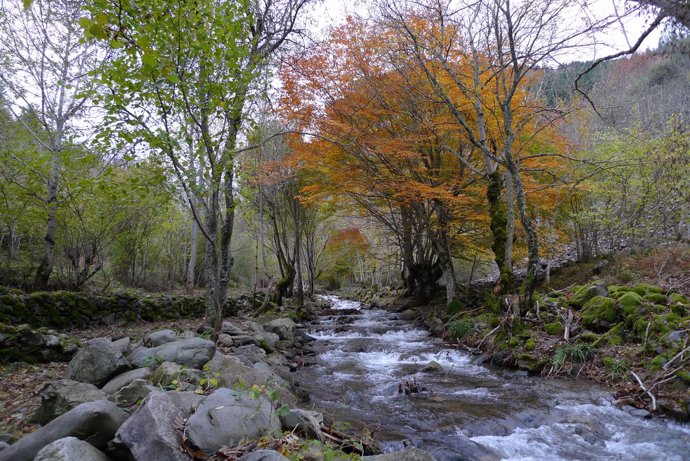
[32,379,107,424]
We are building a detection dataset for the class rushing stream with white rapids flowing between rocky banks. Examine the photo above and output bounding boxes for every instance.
[298,296,690,461]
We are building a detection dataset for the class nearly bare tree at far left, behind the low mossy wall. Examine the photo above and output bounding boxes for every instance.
[0,0,104,289]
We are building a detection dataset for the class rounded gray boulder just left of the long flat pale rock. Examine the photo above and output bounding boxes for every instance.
[67,338,130,386]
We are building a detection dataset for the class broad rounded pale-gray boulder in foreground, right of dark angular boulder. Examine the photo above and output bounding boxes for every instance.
[185,387,280,456]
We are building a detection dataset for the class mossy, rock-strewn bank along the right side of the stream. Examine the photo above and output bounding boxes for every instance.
[344,258,690,421]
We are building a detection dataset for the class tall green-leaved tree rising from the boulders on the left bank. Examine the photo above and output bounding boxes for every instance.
[82,0,308,334]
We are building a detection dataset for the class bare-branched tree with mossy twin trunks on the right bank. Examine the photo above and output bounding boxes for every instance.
[379,0,590,306]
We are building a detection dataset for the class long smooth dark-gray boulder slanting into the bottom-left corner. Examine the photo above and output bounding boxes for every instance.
[0,400,126,461]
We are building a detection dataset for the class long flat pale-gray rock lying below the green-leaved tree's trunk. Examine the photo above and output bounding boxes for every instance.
[130,338,216,368]
